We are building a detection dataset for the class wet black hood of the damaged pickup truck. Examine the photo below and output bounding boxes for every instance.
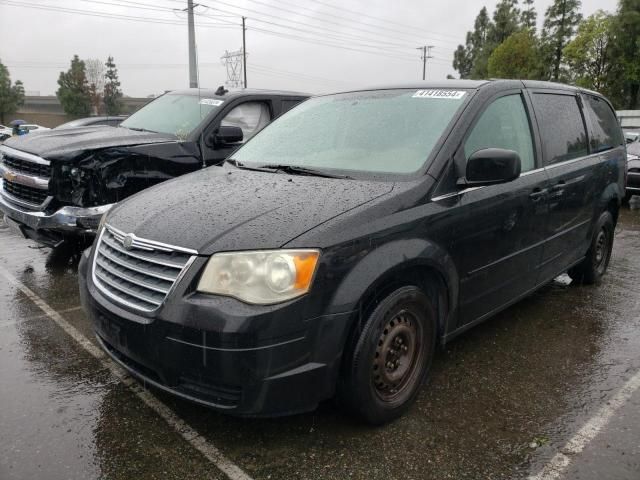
[4,126,176,159]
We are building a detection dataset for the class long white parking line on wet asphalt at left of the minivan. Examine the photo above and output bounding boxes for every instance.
[0,267,252,480]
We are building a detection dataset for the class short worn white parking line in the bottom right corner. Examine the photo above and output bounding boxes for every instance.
[529,366,640,480]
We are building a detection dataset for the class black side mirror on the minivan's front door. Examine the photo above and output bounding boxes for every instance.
[459,148,522,187]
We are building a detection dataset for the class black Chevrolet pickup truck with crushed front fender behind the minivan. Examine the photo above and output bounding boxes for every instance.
[0,87,308,247]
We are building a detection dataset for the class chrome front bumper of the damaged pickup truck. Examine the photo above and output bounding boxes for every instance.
[0,194,113,246]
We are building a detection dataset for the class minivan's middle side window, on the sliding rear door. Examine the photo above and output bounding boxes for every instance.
[533,93,589,165]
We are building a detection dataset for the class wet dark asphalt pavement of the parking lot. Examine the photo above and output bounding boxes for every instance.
[0,204,640,480]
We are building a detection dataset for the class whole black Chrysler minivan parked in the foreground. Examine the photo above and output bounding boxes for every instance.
[80,80,626,423]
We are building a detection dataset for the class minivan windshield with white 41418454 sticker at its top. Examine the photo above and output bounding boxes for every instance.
[233,89,468,174]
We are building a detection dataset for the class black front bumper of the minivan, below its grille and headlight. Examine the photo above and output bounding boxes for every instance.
[79,251,351,416]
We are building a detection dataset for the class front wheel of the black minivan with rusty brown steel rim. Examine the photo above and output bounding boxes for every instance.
[338,286,436,425]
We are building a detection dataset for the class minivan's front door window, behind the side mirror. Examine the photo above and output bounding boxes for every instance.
[464,94,535,172]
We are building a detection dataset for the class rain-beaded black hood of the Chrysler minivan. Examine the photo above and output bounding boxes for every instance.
[107,166,393,255]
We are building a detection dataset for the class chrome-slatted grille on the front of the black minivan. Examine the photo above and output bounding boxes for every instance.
[93,226,196,312]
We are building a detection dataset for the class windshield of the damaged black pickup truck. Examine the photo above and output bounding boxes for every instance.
[120,93,222,140]
